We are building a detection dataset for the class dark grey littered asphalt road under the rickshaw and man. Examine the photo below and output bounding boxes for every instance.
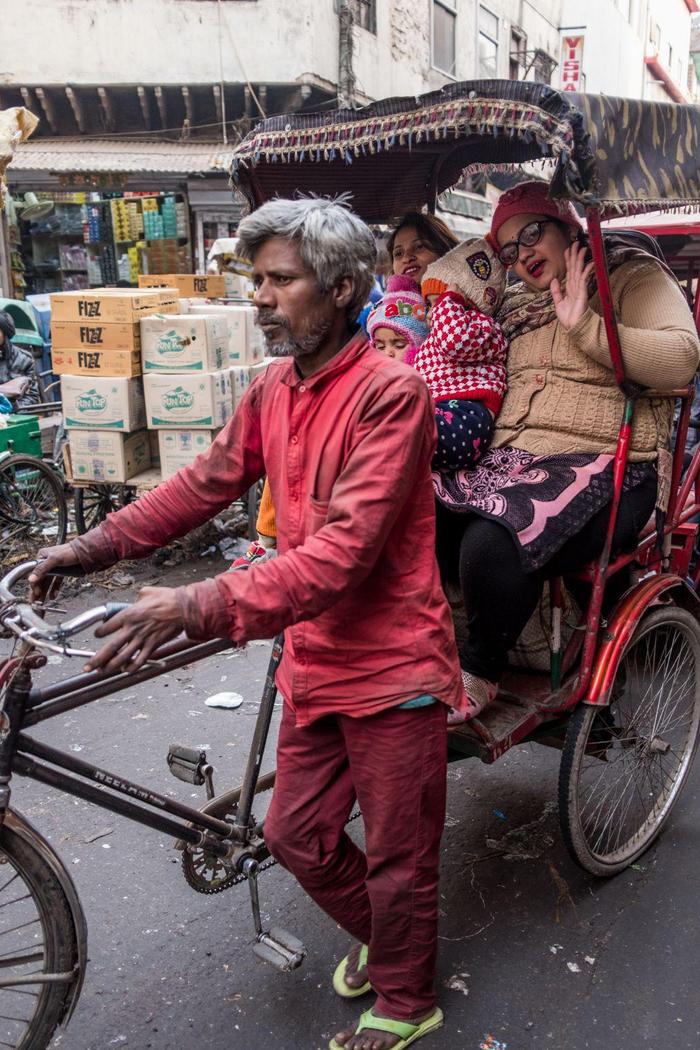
[1,561,700,1050]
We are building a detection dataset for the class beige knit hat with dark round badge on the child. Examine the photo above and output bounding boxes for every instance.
[421,237,506,314]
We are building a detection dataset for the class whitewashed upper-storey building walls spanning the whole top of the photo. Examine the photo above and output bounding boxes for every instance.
[0,0,691,101]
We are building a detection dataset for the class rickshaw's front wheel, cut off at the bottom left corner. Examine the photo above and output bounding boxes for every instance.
[0,827,78,1050]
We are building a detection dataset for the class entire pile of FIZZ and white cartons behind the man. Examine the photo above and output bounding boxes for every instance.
[51,274,267,491]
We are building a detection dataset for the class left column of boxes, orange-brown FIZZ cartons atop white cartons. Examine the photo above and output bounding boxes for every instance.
[51,289,177,482]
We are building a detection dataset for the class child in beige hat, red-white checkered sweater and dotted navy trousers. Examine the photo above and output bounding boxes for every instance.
[415,239,508,471]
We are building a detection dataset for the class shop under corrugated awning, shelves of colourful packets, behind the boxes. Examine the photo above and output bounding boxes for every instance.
[3,140,241,298]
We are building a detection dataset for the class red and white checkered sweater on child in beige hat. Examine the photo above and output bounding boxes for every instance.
[405,291,508,416]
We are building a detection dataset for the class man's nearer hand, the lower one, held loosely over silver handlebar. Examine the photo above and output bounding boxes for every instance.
[86,588,184,672]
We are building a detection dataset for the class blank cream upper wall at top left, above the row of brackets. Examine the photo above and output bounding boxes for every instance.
[3,0,338,85]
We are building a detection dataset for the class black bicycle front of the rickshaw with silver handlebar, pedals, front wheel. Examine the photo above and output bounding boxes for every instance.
[0,562,289,1050]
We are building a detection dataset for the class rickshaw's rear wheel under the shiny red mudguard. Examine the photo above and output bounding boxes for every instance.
[559,606,700,876]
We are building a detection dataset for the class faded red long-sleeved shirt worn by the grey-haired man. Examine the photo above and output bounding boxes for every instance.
[77,335,465,726]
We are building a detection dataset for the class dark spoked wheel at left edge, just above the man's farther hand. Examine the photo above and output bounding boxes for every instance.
[0,455,68,566]
